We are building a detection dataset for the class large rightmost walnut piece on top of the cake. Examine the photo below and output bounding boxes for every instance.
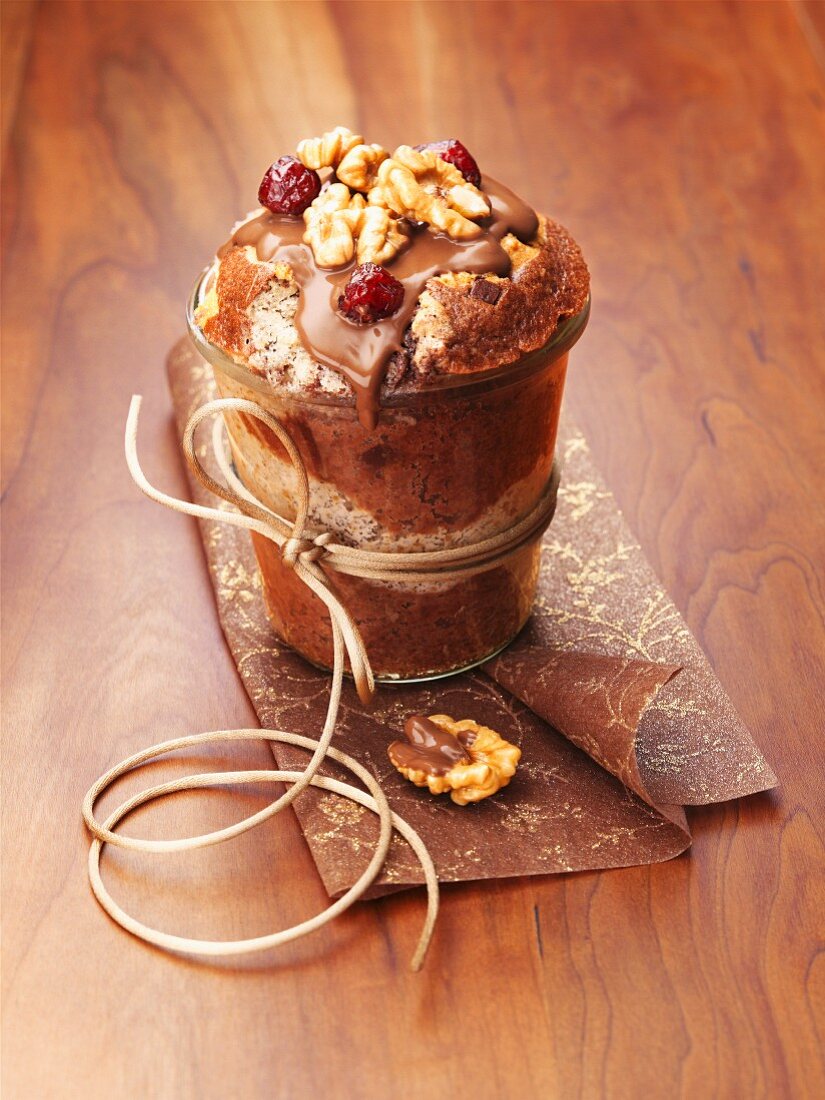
[370,145,491,240]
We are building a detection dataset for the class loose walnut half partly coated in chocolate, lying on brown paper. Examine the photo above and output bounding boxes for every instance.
[387,714,521,806]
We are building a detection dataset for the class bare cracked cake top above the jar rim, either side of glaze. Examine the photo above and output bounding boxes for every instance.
[196,216,590,397]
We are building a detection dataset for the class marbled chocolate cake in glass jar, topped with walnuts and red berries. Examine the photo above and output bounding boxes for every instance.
[189,128,590,680]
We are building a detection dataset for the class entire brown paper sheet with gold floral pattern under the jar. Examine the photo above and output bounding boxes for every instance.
[162,341,776,895]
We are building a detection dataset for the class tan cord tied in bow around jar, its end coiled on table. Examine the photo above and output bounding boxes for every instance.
[83,396,559,970]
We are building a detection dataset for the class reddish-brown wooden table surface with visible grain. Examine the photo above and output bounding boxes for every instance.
[2,2,825,1100]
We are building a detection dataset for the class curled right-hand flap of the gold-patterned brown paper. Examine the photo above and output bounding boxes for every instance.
[487,421,777,805]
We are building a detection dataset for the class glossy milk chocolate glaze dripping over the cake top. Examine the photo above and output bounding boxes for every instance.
[218,178,538,430]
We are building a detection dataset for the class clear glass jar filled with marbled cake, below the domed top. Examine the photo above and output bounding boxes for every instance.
[187,273,590,681]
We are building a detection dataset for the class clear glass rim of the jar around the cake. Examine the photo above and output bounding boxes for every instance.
[186,263,591,408]
